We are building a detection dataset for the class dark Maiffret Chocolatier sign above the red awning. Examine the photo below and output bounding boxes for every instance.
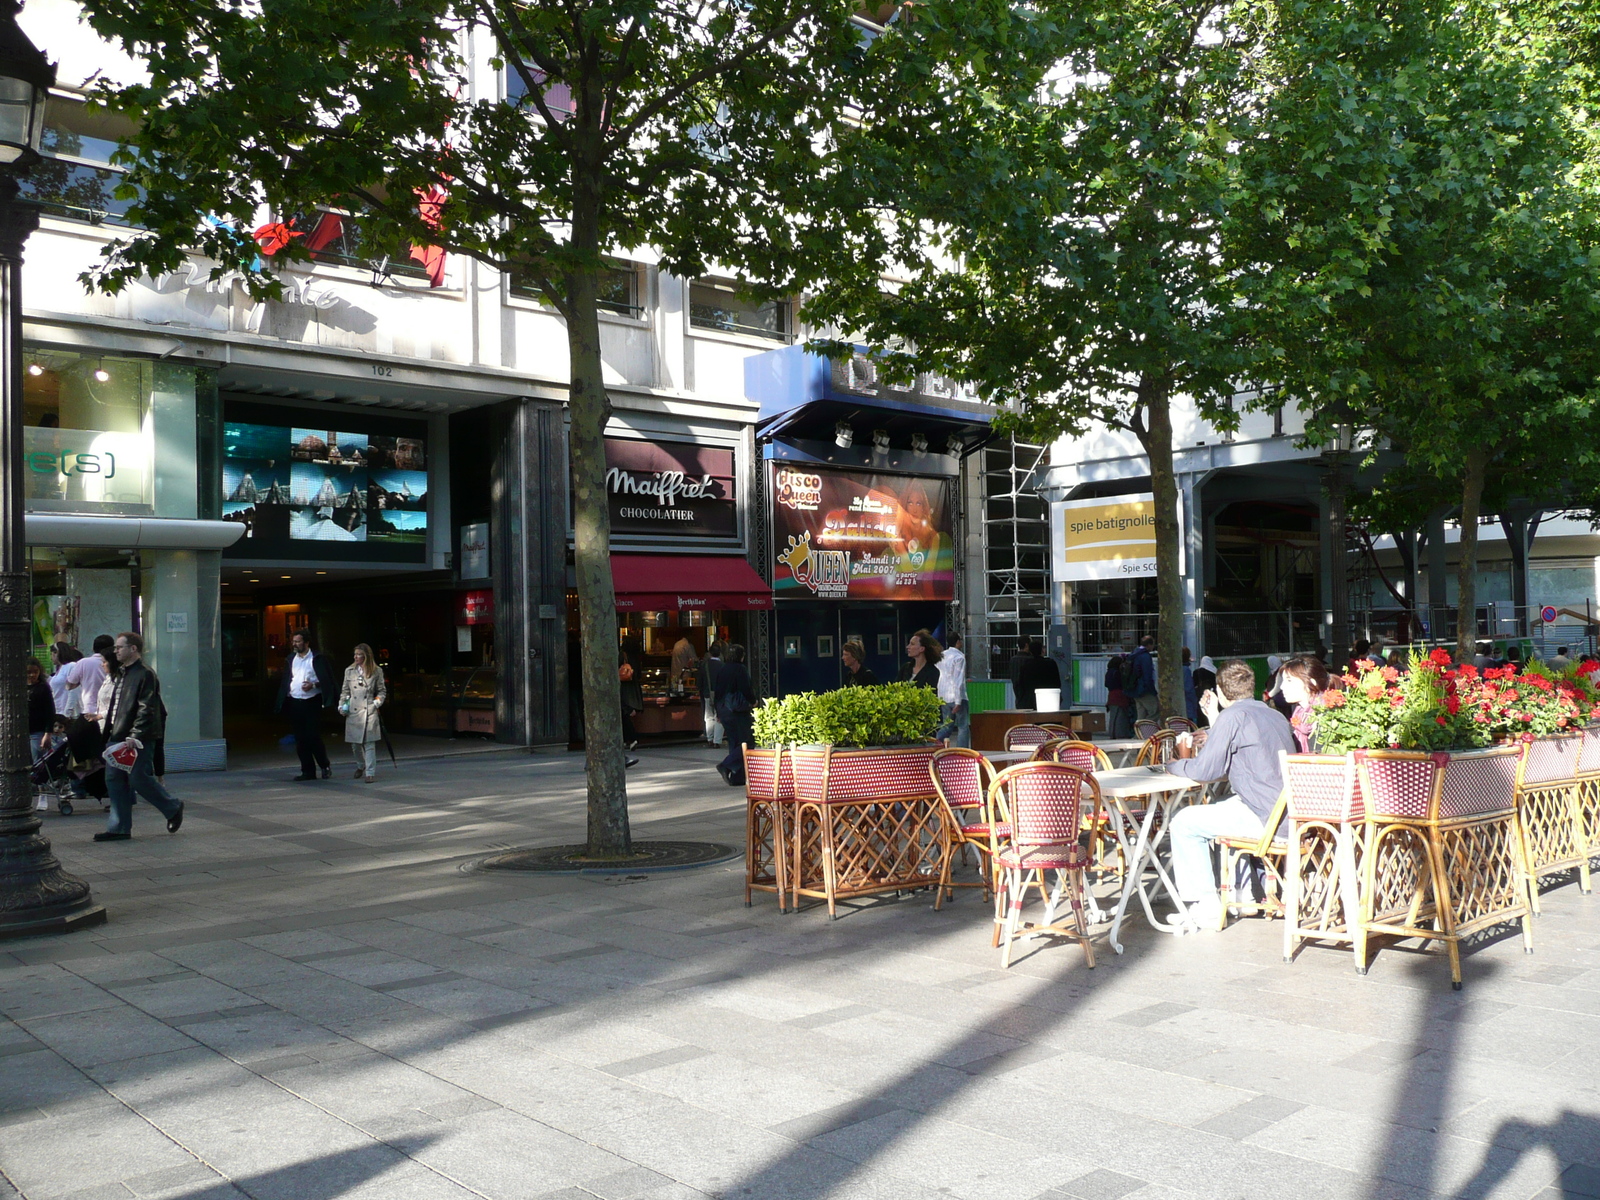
[605,437,739,537]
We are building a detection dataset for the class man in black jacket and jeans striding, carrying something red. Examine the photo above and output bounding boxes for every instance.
[94,634,184,842]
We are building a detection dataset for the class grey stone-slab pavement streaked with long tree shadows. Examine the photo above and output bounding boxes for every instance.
[0,749,1600,1200]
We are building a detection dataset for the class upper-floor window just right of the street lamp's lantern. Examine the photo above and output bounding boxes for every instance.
[21,93,139,226]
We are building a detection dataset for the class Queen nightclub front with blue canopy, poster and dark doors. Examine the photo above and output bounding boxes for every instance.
[746,347,990,694]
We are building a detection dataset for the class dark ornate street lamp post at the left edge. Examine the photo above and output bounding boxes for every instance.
[0,0,106,938]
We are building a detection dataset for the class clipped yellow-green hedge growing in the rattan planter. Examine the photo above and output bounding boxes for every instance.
[755,683,939,747]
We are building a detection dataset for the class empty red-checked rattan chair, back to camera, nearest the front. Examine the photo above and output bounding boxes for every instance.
[989,763,1099,968]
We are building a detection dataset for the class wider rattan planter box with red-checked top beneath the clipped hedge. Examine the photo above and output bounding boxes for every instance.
[787,742,944,917]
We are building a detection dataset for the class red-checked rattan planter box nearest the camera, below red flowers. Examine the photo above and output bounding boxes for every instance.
[1355,746,1533,990]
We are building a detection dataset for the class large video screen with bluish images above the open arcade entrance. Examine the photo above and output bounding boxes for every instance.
[222,406,427,558]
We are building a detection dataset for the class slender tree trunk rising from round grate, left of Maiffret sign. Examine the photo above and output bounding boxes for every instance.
[566,203,632,858]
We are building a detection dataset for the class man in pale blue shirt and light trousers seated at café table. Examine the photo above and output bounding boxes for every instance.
[1166,658,1296,930]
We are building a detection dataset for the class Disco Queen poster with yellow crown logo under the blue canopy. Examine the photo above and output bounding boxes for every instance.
[773,462,955,600]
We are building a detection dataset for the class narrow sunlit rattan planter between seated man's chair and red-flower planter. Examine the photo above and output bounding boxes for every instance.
[1280,754,1366,962]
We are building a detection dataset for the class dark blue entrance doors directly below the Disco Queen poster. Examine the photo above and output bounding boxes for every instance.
[776,600,944,696]
